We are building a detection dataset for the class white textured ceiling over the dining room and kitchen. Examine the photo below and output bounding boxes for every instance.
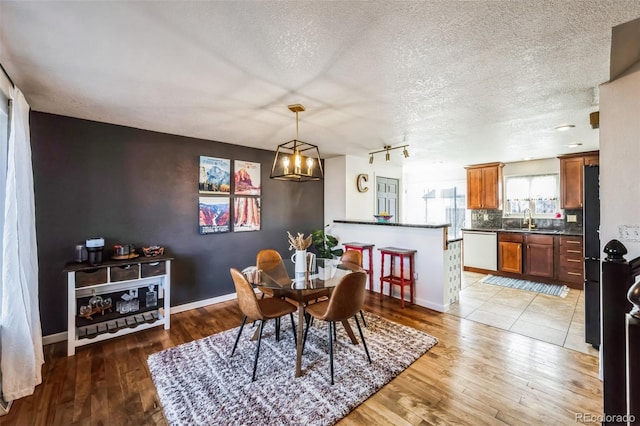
[0,0,640,174]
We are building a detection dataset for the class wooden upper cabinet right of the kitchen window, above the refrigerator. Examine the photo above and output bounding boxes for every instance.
[558,151,599,209]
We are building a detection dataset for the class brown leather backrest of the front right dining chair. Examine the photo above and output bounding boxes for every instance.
[323,271,367,321]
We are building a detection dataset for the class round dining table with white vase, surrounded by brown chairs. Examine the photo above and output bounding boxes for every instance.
[256,255,363,377]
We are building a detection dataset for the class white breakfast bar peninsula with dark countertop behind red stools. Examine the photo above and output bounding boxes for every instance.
[328,220,462,312]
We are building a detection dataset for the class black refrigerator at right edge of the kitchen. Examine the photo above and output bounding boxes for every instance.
[582,165,600,349]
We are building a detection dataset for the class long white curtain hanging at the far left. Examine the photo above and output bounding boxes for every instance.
[0,88,44,401]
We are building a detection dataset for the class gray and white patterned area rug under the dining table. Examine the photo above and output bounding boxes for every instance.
[147,313,438,425]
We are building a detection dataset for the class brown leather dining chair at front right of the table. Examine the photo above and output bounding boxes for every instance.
[305,271,371,385]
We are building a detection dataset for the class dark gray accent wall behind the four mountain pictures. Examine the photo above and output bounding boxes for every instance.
[30,112,324,335]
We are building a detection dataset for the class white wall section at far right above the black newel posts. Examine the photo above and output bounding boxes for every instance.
[600,63,640,260]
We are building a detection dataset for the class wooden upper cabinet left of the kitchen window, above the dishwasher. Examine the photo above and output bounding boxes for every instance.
[465,163,504,209]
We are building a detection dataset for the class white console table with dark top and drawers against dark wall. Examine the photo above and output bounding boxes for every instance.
[64,255,173,356]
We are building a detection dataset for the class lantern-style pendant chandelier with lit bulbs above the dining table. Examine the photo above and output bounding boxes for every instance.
[271,104,324,182]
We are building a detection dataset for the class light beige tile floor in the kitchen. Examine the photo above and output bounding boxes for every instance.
[447,272,598,356]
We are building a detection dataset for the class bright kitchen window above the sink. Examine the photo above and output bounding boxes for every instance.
[504,174,561,218]
